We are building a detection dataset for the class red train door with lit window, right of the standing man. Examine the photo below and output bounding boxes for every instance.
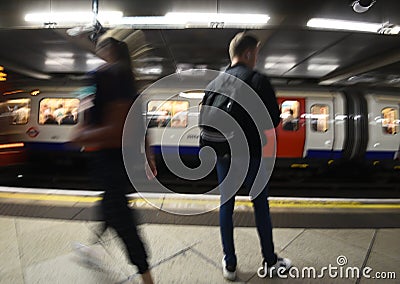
[276,97,306,158]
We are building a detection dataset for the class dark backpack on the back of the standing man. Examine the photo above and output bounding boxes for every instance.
[199,71,255,149]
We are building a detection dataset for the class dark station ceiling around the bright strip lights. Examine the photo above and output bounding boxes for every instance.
[0,0,400,88]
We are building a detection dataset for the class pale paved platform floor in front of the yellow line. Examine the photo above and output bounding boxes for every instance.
[0,216,400,284]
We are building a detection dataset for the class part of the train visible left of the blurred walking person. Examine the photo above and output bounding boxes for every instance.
[0,87,89,169]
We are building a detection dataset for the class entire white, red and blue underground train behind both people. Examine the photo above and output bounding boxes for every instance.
[0,82,400,178]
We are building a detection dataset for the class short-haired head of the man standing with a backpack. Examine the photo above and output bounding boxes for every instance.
[229,32,259,68]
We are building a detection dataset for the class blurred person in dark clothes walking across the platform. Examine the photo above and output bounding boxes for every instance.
[73,37,157,284]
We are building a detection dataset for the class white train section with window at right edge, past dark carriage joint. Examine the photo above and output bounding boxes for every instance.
[366,95,400,160]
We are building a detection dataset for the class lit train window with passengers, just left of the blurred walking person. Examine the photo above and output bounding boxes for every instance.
[39,98,79,125]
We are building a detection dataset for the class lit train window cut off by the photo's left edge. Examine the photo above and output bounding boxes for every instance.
[0,99,31,125]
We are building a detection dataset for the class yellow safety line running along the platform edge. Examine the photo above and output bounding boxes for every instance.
[0,192,400,209]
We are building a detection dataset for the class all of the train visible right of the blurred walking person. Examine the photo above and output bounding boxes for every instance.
[145,87,400,180]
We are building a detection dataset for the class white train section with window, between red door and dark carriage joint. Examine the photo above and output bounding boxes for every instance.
[304,97,335,159]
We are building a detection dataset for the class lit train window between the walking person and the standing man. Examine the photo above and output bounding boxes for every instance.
[147,101,189,128]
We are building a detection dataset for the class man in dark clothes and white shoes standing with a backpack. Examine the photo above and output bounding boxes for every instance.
[199,33,291,281]
